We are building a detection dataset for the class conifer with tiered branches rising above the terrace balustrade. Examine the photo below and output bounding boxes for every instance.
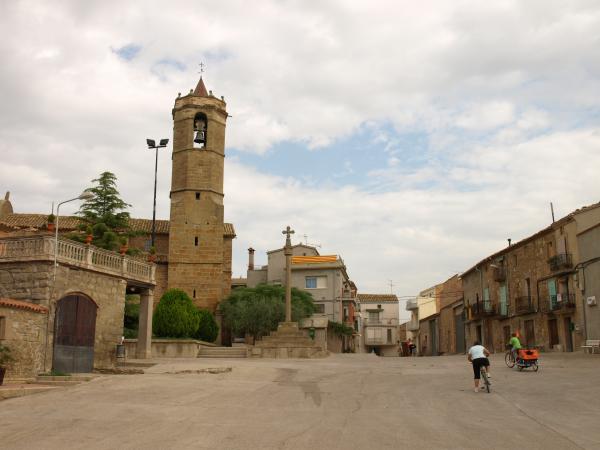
[79,172,131,230]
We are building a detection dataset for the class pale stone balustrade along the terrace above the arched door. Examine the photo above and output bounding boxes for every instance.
[0,236,155,284]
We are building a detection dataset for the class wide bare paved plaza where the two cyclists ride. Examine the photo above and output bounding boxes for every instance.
[0,353,600,450]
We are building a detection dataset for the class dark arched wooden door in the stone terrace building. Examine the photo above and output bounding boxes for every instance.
[52,294,98,373]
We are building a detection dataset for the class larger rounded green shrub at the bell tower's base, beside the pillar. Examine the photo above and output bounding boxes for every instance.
[152,289,200,338]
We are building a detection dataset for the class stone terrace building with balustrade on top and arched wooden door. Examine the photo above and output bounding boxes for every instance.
[0,234,154,377]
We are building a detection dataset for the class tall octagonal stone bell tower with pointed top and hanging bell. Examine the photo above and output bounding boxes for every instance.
[168,77,227,311]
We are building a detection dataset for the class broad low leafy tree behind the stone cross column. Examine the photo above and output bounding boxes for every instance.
[219,284,315,339]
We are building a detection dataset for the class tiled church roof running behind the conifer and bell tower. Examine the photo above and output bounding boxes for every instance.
[0,214,235,238]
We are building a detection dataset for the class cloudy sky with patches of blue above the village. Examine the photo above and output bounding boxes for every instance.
[0,0,600,322]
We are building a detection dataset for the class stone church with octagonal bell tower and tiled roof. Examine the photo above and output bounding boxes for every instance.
[0,79,235,312]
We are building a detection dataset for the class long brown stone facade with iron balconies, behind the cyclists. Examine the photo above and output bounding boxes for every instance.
[462,204,600,352]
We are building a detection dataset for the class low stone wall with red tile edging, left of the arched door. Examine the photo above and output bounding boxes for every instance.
[0,306,48,379]
